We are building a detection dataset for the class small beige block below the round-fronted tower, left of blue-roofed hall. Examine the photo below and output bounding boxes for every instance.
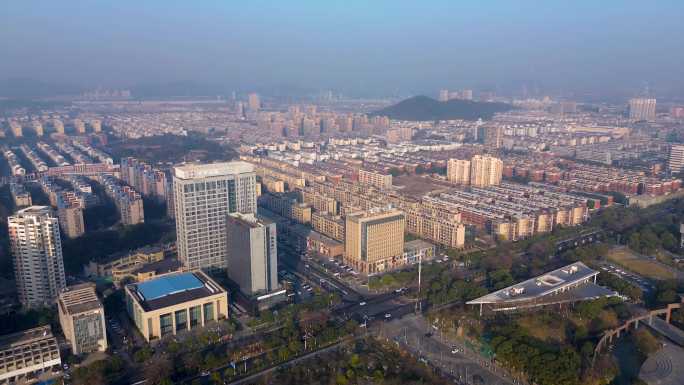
[57,283,107,355]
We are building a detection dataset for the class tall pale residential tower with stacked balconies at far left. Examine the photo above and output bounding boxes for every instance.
[7,206,66,308]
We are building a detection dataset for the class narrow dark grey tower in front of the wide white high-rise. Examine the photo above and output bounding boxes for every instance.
[227,213,278,296]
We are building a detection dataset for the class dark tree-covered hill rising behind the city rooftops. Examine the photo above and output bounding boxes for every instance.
[371,95,514,121]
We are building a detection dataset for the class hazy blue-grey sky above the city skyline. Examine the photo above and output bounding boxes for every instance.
[0,0,684,96]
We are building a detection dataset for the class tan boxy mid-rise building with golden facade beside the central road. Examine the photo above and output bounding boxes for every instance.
[344,209,405,274]
